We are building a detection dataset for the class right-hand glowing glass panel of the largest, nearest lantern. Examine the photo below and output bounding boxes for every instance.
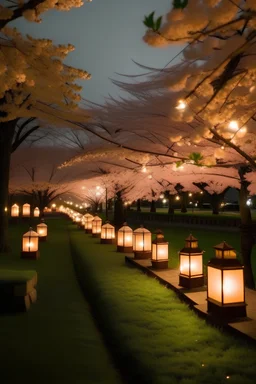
[223,269,244,304]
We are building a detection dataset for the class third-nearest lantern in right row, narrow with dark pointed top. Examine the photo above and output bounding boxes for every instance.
[151,230,169,269]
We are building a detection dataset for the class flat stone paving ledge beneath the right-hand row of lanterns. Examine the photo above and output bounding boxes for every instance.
[125,255,256,341]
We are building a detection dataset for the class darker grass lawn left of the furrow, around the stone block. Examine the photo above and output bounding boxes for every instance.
[0,218,121,384]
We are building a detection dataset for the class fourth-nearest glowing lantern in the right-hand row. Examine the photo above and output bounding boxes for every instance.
[133,226,152,259]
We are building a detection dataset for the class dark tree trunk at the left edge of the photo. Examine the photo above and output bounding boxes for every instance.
[0,119,17,252]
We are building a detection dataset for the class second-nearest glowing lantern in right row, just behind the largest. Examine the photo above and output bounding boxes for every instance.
[179,235,204,288]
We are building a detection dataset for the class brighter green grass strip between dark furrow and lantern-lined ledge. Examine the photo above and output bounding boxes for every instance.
[70,227,256,384]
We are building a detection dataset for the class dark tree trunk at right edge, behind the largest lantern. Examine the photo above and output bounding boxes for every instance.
[239,180,255,289]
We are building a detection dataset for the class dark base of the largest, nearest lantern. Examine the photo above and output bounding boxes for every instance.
[207,299,246,323]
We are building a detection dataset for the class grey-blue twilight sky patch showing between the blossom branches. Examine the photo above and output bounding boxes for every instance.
[15,0,180,103]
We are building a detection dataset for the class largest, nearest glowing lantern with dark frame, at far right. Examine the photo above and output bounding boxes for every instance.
[207,241,246,321]
